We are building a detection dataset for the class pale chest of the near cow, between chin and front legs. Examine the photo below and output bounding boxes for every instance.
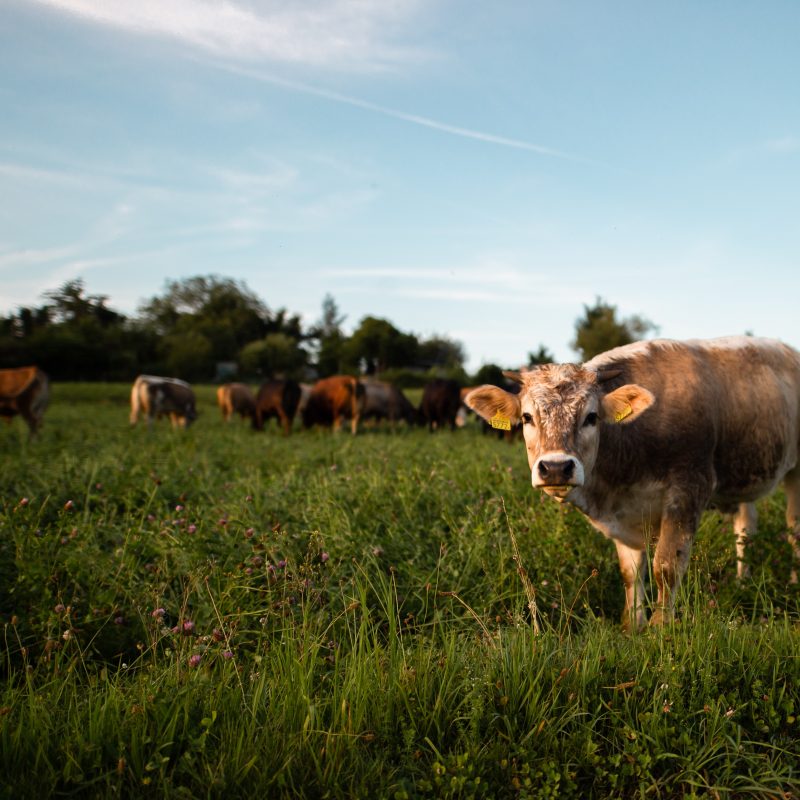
[568,483,664,550]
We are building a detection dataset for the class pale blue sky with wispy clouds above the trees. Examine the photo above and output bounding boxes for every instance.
[0,0,800,370]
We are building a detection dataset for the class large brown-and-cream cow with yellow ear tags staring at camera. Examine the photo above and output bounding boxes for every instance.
[466,336,800,629]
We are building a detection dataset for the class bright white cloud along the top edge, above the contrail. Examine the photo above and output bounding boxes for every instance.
[29,0,430,70]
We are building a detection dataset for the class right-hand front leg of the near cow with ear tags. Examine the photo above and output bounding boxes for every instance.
[650,507,699,625]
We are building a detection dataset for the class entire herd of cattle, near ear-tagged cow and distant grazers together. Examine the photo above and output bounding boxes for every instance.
[0,336,800,629]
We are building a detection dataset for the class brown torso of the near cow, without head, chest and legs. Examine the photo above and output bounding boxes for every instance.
[585,337,800,506]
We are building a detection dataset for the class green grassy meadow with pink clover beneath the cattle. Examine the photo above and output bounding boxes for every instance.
[0,384,800,800]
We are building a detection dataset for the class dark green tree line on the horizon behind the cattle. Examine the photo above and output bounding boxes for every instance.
[0,275,654,386]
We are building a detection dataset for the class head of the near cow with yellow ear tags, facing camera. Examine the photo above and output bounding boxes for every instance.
[465,364,655,499]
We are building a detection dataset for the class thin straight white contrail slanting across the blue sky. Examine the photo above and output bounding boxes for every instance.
[206,59,595,164]
